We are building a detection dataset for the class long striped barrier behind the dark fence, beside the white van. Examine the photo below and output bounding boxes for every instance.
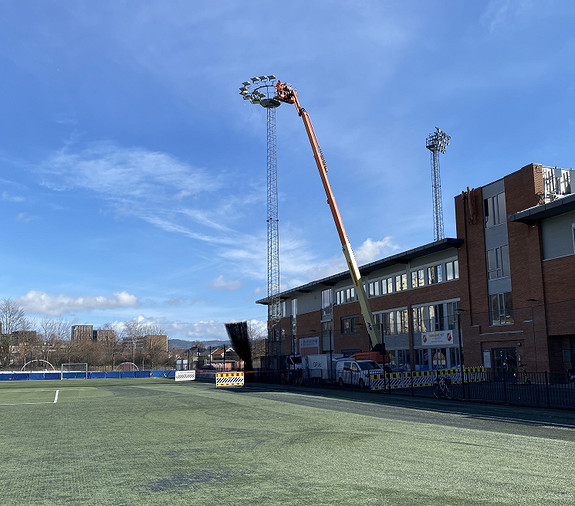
[369,367,487,390]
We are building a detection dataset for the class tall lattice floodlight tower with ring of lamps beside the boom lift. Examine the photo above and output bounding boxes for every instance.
[240,75,281,357]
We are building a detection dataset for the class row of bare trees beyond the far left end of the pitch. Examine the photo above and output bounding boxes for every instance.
[0,299,169,369]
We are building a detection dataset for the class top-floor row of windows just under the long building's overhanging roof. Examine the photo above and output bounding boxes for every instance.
[336,260,459,304]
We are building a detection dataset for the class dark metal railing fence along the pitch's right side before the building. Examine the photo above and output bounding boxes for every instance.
[370,369,575,409]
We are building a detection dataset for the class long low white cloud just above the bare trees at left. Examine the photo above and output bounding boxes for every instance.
[14,290,139,316]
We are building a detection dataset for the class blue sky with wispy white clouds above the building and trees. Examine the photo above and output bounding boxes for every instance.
[0,0,575,340]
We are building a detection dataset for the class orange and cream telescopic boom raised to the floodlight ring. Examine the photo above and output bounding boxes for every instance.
[275,81,382,349]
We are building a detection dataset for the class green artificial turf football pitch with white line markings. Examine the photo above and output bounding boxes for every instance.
[0,379,575,505]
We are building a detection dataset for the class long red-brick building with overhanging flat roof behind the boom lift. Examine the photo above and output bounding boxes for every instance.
[258,164,575,381]
